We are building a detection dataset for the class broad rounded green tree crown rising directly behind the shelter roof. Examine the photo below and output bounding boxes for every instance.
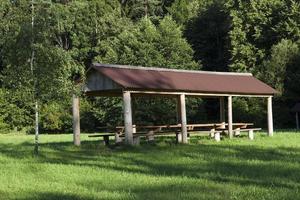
[96,16,199,69]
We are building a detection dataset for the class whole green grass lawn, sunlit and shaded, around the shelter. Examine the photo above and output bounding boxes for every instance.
[0,132,300,200]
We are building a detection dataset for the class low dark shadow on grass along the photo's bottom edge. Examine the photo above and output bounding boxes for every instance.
[11,182,230,200]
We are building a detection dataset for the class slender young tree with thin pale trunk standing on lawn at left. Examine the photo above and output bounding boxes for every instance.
[2,0,81,140]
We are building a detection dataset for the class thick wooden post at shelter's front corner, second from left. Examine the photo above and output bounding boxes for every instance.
[123,91,133,145]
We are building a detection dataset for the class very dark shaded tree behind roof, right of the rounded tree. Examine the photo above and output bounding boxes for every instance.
[185,0,230,71]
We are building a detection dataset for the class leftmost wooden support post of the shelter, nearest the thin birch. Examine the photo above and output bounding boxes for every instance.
[72,94,80,146]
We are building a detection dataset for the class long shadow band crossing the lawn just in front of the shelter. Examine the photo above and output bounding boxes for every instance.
[0,136,300,189]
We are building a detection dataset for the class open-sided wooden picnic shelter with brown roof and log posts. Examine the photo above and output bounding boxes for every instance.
[73,64,277,144]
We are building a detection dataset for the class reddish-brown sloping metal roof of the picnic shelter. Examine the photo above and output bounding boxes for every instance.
[92,64,277,95]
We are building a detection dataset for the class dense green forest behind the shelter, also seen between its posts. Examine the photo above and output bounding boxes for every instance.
[0,0,300,133]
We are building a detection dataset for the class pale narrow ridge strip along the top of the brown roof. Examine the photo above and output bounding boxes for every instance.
[92,63,252,76]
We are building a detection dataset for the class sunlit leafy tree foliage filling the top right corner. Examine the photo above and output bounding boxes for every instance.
[227,0,300,72]
